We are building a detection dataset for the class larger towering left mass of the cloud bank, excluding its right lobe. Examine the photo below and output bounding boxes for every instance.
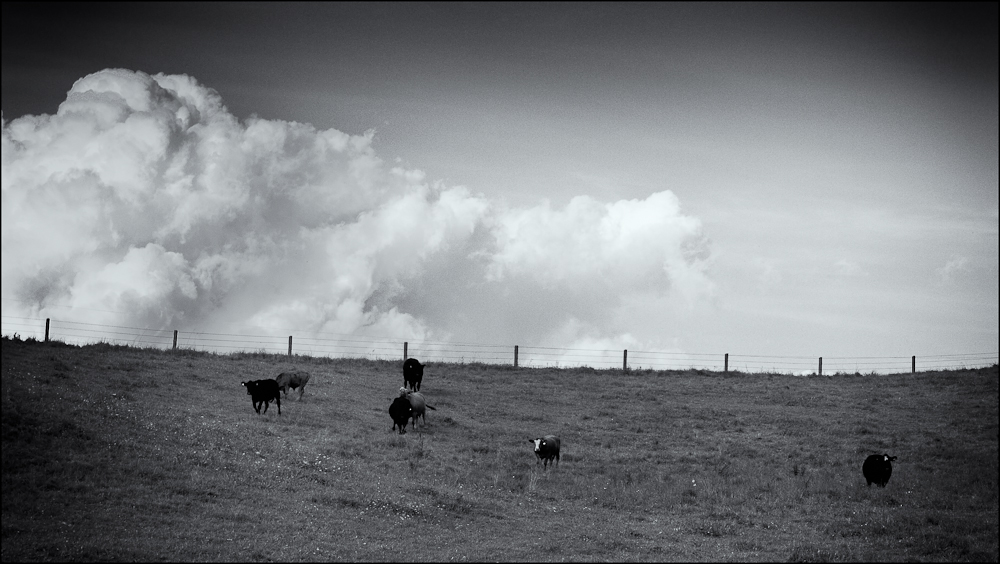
[3,69,487,342]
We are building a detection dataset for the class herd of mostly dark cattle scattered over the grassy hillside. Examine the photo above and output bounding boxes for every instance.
[241,358,896,480]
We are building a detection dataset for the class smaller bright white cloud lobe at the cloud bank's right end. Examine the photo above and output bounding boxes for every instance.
[489,191,712,298]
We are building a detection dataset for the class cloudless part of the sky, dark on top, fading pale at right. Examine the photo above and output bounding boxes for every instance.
[2,2,998,364]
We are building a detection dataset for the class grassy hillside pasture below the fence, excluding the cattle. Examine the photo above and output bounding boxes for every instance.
[2,338,998,561]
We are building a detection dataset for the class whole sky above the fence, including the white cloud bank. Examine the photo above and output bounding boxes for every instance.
[2,2,1000,370]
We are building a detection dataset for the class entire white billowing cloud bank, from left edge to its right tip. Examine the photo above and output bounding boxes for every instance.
[2,69,713,356]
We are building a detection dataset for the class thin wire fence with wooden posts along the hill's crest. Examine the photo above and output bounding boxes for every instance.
[0,316,998,375]
